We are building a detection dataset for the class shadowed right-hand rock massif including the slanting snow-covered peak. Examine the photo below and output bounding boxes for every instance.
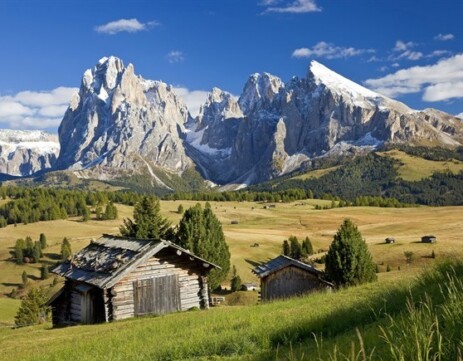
[189,61,463,185]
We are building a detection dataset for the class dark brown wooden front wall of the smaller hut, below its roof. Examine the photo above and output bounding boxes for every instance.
[261,266,324,301]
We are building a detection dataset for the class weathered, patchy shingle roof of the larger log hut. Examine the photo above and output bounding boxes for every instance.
[52,235,220,288]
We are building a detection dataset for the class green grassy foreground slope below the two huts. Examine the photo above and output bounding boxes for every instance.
[0,262,463,361]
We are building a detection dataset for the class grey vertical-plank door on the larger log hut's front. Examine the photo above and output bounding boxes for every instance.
[133,275,181,316]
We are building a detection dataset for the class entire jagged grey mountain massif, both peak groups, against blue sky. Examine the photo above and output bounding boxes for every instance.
[0,57,463,188]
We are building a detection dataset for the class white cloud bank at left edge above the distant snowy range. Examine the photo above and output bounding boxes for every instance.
[0,87,78,129]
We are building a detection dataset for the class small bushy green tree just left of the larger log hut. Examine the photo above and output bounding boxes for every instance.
[15,288,49,327]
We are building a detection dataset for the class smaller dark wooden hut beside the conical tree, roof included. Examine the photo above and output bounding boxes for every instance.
[253,255,333,301]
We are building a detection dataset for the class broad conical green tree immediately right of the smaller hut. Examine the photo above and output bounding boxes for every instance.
[325,219,377,286]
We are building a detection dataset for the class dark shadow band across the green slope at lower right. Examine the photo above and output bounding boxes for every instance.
[269,262,463,348]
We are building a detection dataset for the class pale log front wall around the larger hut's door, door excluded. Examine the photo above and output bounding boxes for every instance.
[110,255,202,320]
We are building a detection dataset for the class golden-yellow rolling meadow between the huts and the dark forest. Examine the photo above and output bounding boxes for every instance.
[0,200,463,324]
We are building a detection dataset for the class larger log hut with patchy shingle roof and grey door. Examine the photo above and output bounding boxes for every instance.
[48,235,219,326]
